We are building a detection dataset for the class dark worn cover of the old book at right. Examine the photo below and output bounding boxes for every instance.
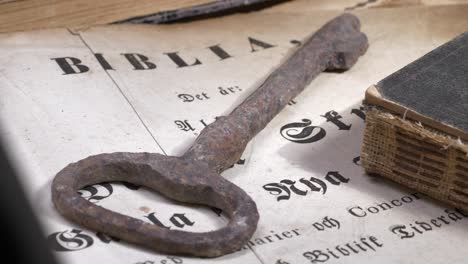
[366,32,468,140]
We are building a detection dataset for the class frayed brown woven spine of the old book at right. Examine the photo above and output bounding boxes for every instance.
[361,106,468,211]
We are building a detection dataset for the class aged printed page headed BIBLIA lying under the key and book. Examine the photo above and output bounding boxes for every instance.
[0,5,468,263]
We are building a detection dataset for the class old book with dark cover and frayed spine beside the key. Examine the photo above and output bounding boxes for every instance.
[361,32,468,210]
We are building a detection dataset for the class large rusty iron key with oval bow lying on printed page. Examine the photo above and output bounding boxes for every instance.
[52,14,368,257]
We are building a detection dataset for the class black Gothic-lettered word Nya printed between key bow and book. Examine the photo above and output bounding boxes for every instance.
[263,171,349,202]
